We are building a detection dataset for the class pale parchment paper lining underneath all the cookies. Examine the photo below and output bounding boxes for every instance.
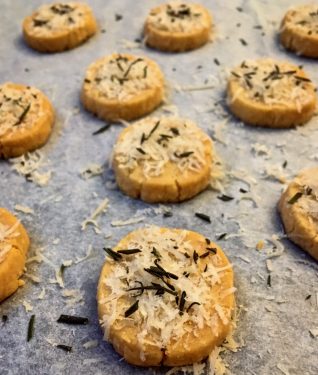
[0,0,318,375]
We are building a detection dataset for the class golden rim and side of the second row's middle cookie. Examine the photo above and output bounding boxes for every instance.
[81,54,164,122]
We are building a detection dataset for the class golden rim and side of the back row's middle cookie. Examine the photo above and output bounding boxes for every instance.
[144,4,212,52]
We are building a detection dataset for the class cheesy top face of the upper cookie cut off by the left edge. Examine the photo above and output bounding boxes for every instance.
[0,83,43,137]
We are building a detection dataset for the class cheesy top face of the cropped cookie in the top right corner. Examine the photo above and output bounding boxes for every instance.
[282,4,318,35]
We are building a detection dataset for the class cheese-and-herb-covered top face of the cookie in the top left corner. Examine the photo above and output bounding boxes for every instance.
[25,2,90,37]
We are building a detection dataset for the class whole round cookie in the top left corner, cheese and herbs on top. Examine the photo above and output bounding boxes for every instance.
[23,2,97,52]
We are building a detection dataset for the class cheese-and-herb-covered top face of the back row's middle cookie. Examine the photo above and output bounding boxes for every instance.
[147,0,211,33]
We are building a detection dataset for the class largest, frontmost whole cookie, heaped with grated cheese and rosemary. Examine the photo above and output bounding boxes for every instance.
[97,226,235,366]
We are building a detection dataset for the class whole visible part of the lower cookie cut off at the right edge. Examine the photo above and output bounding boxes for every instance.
[278,168,318,260]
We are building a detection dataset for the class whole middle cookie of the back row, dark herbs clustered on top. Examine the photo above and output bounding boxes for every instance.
[144,1,212,52]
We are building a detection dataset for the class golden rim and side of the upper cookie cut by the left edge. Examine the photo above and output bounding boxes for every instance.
[0,83,54,158]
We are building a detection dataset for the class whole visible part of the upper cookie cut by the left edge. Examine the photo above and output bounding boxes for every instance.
[0,82,54,158]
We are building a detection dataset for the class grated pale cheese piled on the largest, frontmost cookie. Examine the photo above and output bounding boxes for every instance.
[99,226,235,359]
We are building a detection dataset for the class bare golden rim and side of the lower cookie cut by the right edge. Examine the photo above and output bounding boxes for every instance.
[278,168,318,260]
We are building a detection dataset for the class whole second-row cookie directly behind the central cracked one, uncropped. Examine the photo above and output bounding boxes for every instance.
[81,54,164,121]
